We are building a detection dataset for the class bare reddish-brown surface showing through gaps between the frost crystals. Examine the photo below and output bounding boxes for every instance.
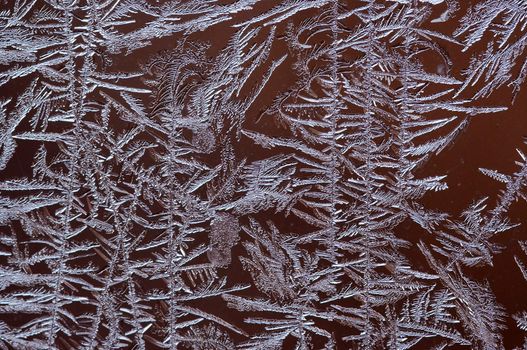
[0,1,527,349]
